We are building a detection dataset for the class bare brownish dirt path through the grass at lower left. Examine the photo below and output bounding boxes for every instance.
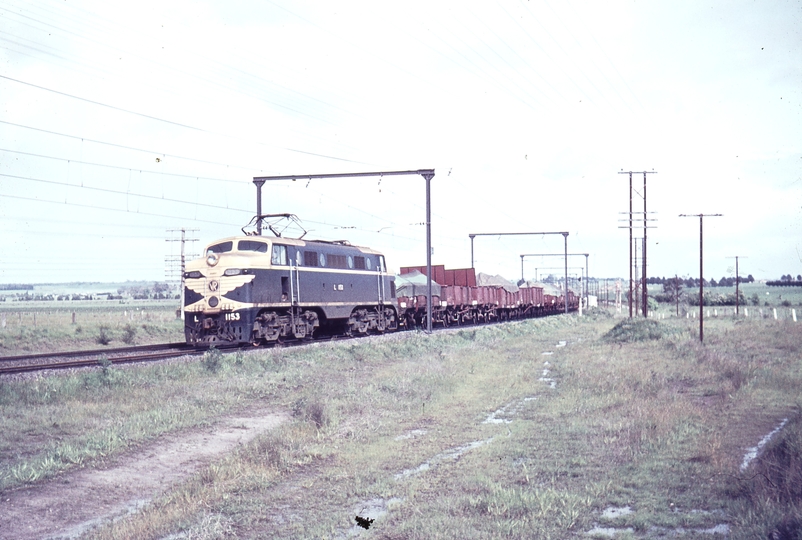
[0,411,288,540]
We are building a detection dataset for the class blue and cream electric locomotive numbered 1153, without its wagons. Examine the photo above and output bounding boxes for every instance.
[184,235,398,346]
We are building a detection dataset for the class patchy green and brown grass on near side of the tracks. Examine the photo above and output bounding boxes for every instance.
[0,312,802,539]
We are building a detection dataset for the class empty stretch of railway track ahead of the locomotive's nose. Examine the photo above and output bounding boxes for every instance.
[0,343,211,375]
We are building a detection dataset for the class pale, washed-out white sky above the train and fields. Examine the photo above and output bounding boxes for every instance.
[0,0,802,283]
